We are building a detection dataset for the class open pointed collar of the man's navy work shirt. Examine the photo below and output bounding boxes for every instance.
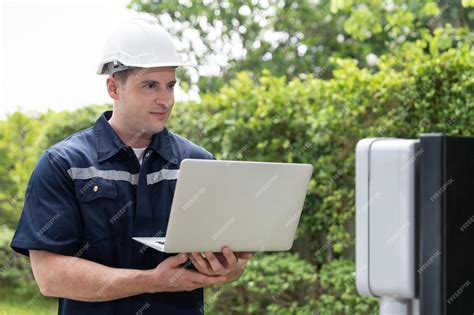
[93,111,177,164]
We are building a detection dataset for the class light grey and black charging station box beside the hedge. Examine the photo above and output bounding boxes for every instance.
[356,134,474,315]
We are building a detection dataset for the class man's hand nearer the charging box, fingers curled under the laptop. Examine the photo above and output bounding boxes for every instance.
[189,246,252,281]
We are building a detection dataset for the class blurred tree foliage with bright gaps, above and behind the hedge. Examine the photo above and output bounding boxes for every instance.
[129,0,474,91]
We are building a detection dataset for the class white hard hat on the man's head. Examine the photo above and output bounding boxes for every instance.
[97,16,187,74]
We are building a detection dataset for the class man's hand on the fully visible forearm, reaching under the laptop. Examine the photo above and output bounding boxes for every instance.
[149,253,227,293]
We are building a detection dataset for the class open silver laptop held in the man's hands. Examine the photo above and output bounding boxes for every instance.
[133,159,313,253]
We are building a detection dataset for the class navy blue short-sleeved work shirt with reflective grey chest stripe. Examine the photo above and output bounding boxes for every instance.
[11,111,214,315]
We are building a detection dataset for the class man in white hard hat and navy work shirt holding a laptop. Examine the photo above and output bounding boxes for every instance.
[11,19,251,315]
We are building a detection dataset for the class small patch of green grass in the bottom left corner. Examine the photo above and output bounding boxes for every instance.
[0,288,58,315]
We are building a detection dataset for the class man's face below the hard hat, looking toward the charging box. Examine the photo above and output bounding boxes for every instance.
[114,67,176,135]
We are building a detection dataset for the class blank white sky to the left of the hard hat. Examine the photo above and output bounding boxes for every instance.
[0,0,193,119]
